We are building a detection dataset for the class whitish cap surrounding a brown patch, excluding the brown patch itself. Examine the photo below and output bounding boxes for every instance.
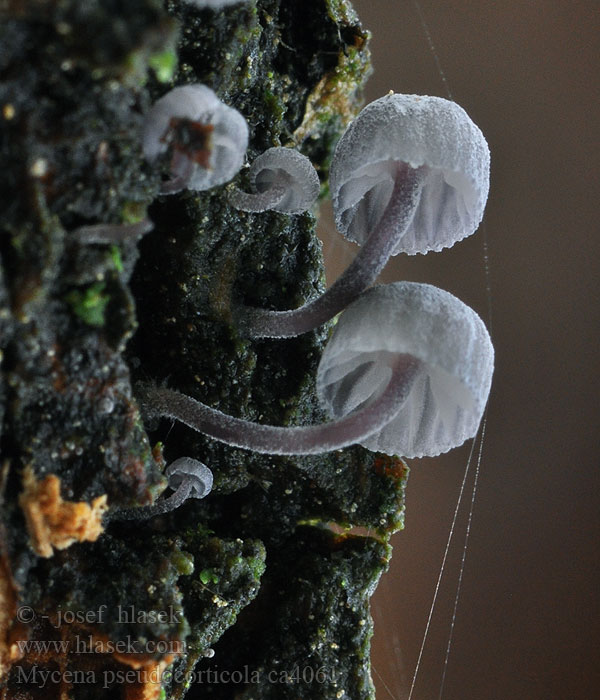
[142,84,248,190]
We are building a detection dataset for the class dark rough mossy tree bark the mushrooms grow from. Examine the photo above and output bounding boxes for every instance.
[0,0,407,699]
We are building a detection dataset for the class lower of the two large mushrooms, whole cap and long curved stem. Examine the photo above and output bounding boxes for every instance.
[140,282,494,457]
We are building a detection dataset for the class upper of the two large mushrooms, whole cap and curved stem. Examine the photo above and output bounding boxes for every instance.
[232,94,490,338]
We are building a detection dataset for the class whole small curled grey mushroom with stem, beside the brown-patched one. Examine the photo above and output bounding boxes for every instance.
[229,147,320,214]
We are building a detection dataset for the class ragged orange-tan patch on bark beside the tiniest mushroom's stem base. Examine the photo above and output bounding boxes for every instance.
[19,468,108,557]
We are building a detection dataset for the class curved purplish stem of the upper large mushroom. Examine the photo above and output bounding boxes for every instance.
[235,168,425,338]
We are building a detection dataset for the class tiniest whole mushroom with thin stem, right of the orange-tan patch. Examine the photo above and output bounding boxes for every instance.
[110,457,213,520]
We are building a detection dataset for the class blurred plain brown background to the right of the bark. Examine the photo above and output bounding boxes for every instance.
[318,0,600,700]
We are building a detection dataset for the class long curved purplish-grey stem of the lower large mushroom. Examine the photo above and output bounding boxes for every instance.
[140,355,421,455]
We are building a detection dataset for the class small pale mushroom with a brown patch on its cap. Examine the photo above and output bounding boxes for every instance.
[142,84,248,194]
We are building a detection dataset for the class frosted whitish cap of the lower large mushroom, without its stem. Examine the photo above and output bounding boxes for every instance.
[317,282,494,457]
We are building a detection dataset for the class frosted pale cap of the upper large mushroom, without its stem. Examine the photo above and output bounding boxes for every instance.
[329,94,490,255]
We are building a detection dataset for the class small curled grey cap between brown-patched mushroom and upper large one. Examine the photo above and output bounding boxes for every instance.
[250,147,320,214]
